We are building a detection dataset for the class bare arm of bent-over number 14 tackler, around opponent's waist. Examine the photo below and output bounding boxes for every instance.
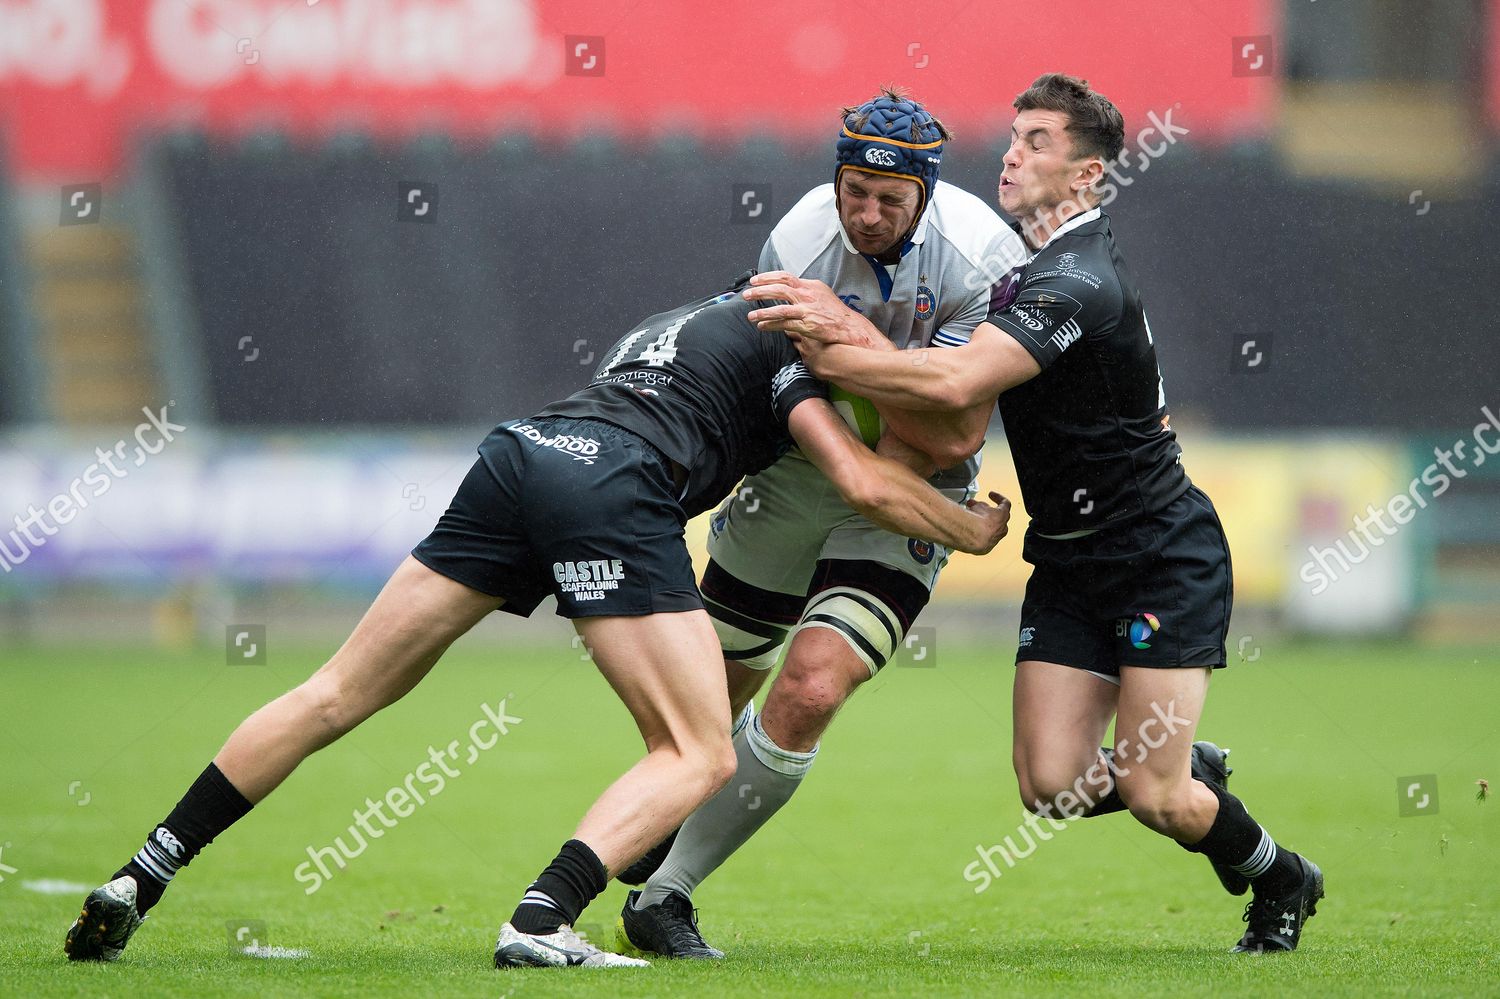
[788,399,1011,555]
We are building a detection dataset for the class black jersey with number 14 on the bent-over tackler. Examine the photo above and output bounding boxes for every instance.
[537,284,828,516]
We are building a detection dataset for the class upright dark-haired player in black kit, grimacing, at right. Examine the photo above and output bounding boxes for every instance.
[746,74,1323,953]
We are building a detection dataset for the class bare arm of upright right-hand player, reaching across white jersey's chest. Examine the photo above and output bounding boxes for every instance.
[792,321,1041,411]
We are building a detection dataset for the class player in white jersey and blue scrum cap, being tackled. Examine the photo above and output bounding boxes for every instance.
[620,89,1026,959]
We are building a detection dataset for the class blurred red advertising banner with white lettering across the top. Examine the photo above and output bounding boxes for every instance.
[0,0,1275,180]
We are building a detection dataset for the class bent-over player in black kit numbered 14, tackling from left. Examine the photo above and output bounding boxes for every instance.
[66,276,1010,968]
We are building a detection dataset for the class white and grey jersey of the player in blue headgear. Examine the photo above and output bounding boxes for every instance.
[758,180,1029,486]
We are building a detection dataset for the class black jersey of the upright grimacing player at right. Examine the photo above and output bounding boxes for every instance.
[986,209,1191,534]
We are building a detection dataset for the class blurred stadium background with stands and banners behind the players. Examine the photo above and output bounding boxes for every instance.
[0,0,1500,645]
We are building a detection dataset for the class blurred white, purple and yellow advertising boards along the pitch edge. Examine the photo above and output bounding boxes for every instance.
[0,429,1476,632]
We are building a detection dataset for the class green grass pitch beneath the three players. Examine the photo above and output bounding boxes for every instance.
[0,639,1500,999]
